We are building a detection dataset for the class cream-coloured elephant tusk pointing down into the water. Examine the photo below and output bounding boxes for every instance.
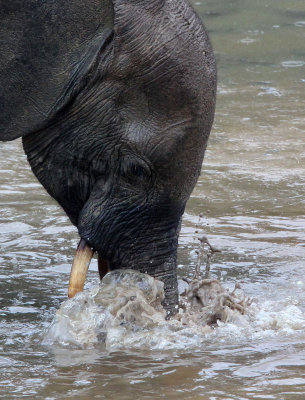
[68,239,94,298]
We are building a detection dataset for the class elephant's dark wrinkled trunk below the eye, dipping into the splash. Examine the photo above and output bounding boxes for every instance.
[78,193,184,315]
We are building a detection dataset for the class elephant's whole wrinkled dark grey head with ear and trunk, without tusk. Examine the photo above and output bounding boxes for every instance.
[0,0,216,313]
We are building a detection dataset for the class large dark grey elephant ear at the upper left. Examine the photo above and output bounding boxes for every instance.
[0,0,113,141]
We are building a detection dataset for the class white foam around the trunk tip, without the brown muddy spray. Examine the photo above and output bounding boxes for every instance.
[43,271,305,351]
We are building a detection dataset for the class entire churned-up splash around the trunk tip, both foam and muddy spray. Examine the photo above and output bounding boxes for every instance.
[44,270,305,351]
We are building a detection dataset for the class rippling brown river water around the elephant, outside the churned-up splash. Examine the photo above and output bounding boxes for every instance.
[0,0,305,400]
